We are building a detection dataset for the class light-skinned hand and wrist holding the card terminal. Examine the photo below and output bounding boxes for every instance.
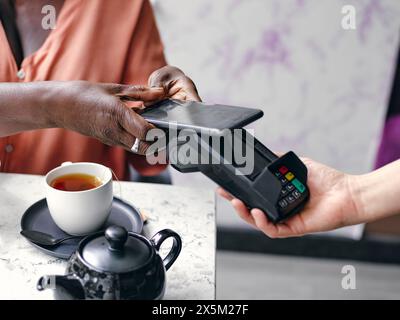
[218,158,400,238]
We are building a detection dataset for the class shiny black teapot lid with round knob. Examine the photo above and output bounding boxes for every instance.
[79,226,153,273]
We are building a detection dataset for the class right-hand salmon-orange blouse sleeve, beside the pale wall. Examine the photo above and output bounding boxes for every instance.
[123,0,167,176]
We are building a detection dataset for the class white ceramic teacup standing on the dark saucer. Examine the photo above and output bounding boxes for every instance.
[46,162,113,235]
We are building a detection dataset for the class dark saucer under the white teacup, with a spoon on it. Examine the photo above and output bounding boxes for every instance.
[21,197,143,259]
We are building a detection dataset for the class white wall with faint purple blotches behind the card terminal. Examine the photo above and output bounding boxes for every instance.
[153,0,400,175]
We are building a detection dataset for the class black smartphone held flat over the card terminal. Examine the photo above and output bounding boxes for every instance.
[141,100,263,133]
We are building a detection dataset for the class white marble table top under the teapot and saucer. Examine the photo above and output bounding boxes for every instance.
[0,173,216,300]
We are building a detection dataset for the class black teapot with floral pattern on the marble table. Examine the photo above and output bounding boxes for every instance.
[37,226,182,300]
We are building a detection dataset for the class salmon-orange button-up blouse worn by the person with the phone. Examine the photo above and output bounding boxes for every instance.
[0,0,166,179]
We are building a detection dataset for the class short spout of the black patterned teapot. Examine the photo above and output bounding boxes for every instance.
[36,275,85,300]
